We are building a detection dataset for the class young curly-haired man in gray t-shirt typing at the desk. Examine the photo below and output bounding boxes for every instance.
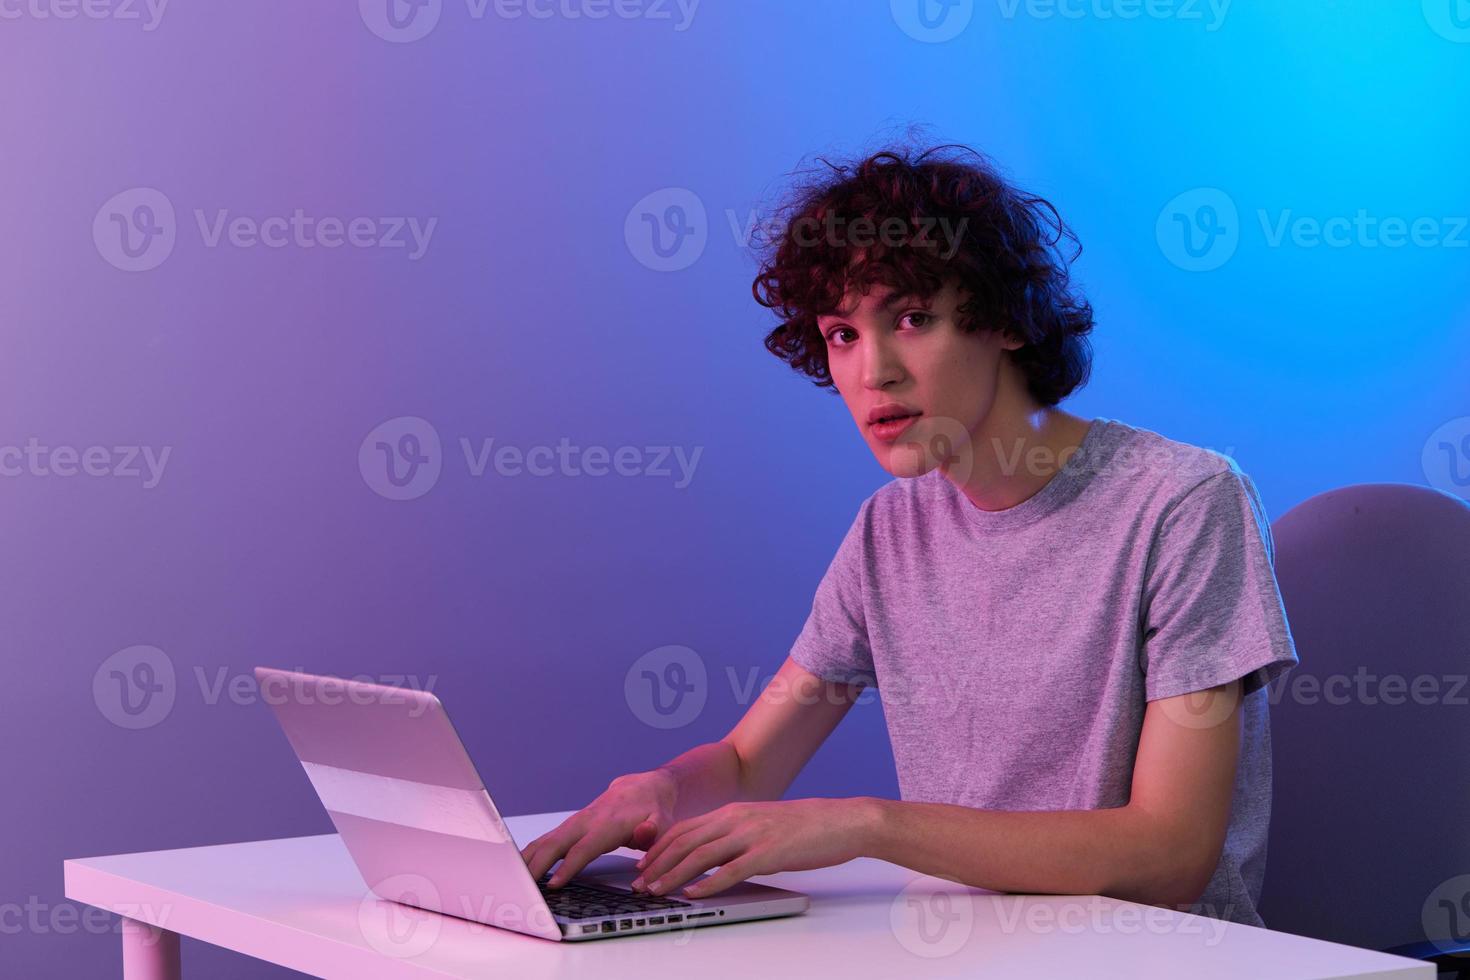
[525,147,1297,924]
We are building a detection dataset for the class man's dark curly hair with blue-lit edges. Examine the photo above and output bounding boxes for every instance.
[751,144,1092,406]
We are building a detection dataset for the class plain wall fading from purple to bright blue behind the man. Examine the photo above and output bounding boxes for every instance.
[0,0,1470,977]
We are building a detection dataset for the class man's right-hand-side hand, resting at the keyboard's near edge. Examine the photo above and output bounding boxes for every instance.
[634,796,881,898]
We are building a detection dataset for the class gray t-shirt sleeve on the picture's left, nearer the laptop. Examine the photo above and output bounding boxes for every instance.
[791,497,878,688]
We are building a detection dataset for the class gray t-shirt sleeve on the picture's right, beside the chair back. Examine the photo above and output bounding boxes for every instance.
[1139,464,1298,701]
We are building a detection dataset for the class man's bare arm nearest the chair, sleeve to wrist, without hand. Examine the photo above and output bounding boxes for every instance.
[863,680,1241,907]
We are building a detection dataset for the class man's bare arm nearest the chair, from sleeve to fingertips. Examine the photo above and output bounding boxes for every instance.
[634,680,1241,907]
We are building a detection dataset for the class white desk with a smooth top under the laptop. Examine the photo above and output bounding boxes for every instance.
[65,813,1435,980]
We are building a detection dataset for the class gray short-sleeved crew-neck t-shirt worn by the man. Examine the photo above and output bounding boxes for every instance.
[791,419,1297,926]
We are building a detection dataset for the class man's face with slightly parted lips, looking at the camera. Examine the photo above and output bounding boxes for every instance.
[817,282,1020,478]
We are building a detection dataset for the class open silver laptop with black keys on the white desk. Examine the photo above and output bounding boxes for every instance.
[254,667,811,942]
